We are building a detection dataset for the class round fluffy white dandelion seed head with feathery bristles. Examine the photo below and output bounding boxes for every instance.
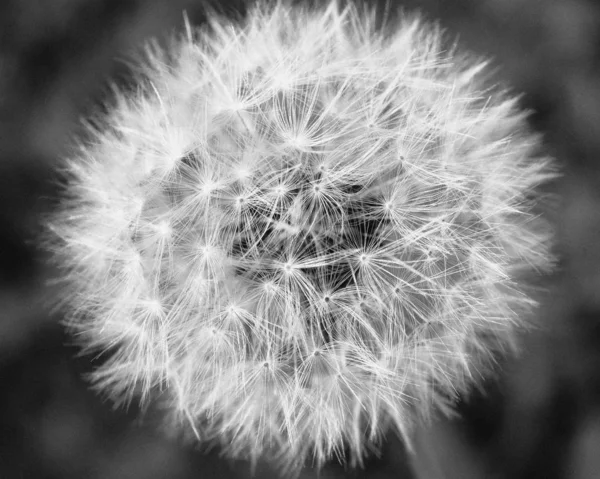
[45,2,554,471]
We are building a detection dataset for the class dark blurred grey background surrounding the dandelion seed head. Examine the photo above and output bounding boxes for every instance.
[0,0,600,479]
